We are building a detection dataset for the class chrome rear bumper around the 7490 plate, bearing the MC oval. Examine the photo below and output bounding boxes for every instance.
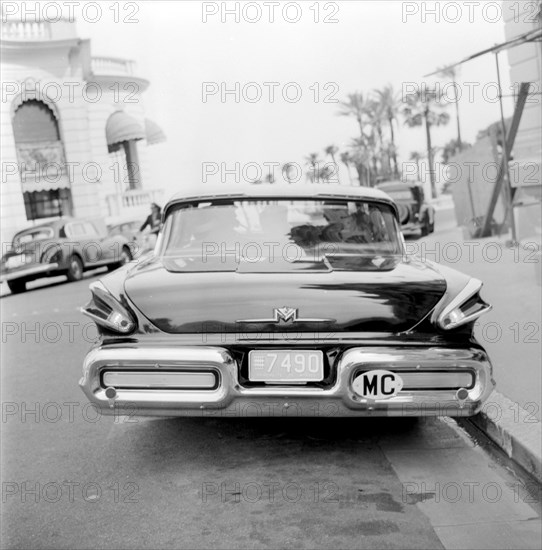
[79,346,495,417]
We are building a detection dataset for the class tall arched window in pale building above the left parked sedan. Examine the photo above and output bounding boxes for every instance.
[13,99,72,220]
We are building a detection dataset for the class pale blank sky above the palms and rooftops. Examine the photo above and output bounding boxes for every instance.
[73,0,513,198]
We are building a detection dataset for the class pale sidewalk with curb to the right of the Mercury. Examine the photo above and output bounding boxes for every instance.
[420,228,542,480]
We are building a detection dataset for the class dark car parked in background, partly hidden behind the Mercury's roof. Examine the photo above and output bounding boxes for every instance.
[377,181,435,237]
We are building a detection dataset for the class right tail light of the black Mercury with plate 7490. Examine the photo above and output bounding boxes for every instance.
[436,279,492,330]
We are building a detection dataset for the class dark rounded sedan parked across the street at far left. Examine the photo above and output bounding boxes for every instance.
[0,218,132,294]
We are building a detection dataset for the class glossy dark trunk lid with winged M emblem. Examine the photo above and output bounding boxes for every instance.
[125,257,446,333]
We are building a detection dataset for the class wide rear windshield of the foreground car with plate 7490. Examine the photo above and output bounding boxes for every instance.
[162,200,402,271]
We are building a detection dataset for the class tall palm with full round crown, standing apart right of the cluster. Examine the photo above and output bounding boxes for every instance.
[403,89,450,202]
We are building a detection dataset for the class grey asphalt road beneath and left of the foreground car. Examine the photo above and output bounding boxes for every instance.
[0,212,541,549]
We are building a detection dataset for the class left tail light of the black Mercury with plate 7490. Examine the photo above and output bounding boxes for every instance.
[81,281,136,334]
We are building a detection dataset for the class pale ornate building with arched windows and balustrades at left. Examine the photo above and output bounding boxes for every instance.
[0,19,165,243]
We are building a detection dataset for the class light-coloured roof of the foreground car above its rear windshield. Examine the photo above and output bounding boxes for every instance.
[164,183,395,212]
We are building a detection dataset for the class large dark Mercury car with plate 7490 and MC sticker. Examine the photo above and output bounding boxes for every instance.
[80,184,494,416]
